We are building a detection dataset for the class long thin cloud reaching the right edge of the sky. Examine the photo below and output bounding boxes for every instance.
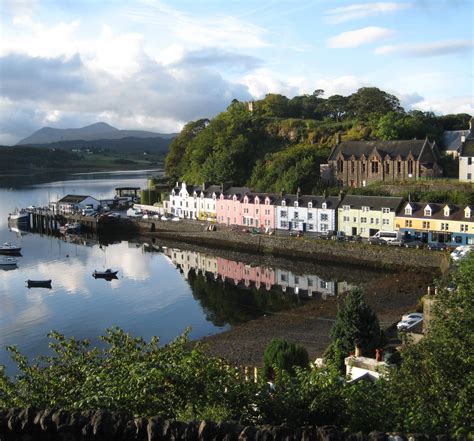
[374,40,473,57]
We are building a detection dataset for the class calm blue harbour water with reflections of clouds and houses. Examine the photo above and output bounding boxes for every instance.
[0,171,352,373]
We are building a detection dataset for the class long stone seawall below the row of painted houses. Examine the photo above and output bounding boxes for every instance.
[131,220,449,272]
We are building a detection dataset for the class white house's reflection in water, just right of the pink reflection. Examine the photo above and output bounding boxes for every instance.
[276,269,336,299]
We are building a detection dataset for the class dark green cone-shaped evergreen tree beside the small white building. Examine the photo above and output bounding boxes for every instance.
[329,288,381,363]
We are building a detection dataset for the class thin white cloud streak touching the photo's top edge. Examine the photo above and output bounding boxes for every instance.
[325,2,412,24]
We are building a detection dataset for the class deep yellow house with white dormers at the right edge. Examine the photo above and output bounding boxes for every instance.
[395,202,474,246]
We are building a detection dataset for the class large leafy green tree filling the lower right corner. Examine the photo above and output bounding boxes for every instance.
[386,253,474,438]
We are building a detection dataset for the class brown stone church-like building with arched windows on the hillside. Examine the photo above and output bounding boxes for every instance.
[322,138,442,187]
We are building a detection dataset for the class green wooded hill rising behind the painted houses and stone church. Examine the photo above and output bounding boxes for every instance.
[166,87,470,193]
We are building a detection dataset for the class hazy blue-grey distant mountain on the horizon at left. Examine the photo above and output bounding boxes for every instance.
[17,122,176,145]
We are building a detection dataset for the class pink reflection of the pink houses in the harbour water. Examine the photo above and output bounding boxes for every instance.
[217,257,275,291]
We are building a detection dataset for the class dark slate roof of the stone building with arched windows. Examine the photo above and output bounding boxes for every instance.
[328,139,441,162]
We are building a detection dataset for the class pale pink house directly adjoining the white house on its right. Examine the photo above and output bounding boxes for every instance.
[242,193,275,230]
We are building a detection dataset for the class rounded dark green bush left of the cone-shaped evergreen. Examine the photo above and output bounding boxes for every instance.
[263,339,309,378]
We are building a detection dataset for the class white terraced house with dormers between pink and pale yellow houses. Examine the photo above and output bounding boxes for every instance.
[275,193,340,233]
